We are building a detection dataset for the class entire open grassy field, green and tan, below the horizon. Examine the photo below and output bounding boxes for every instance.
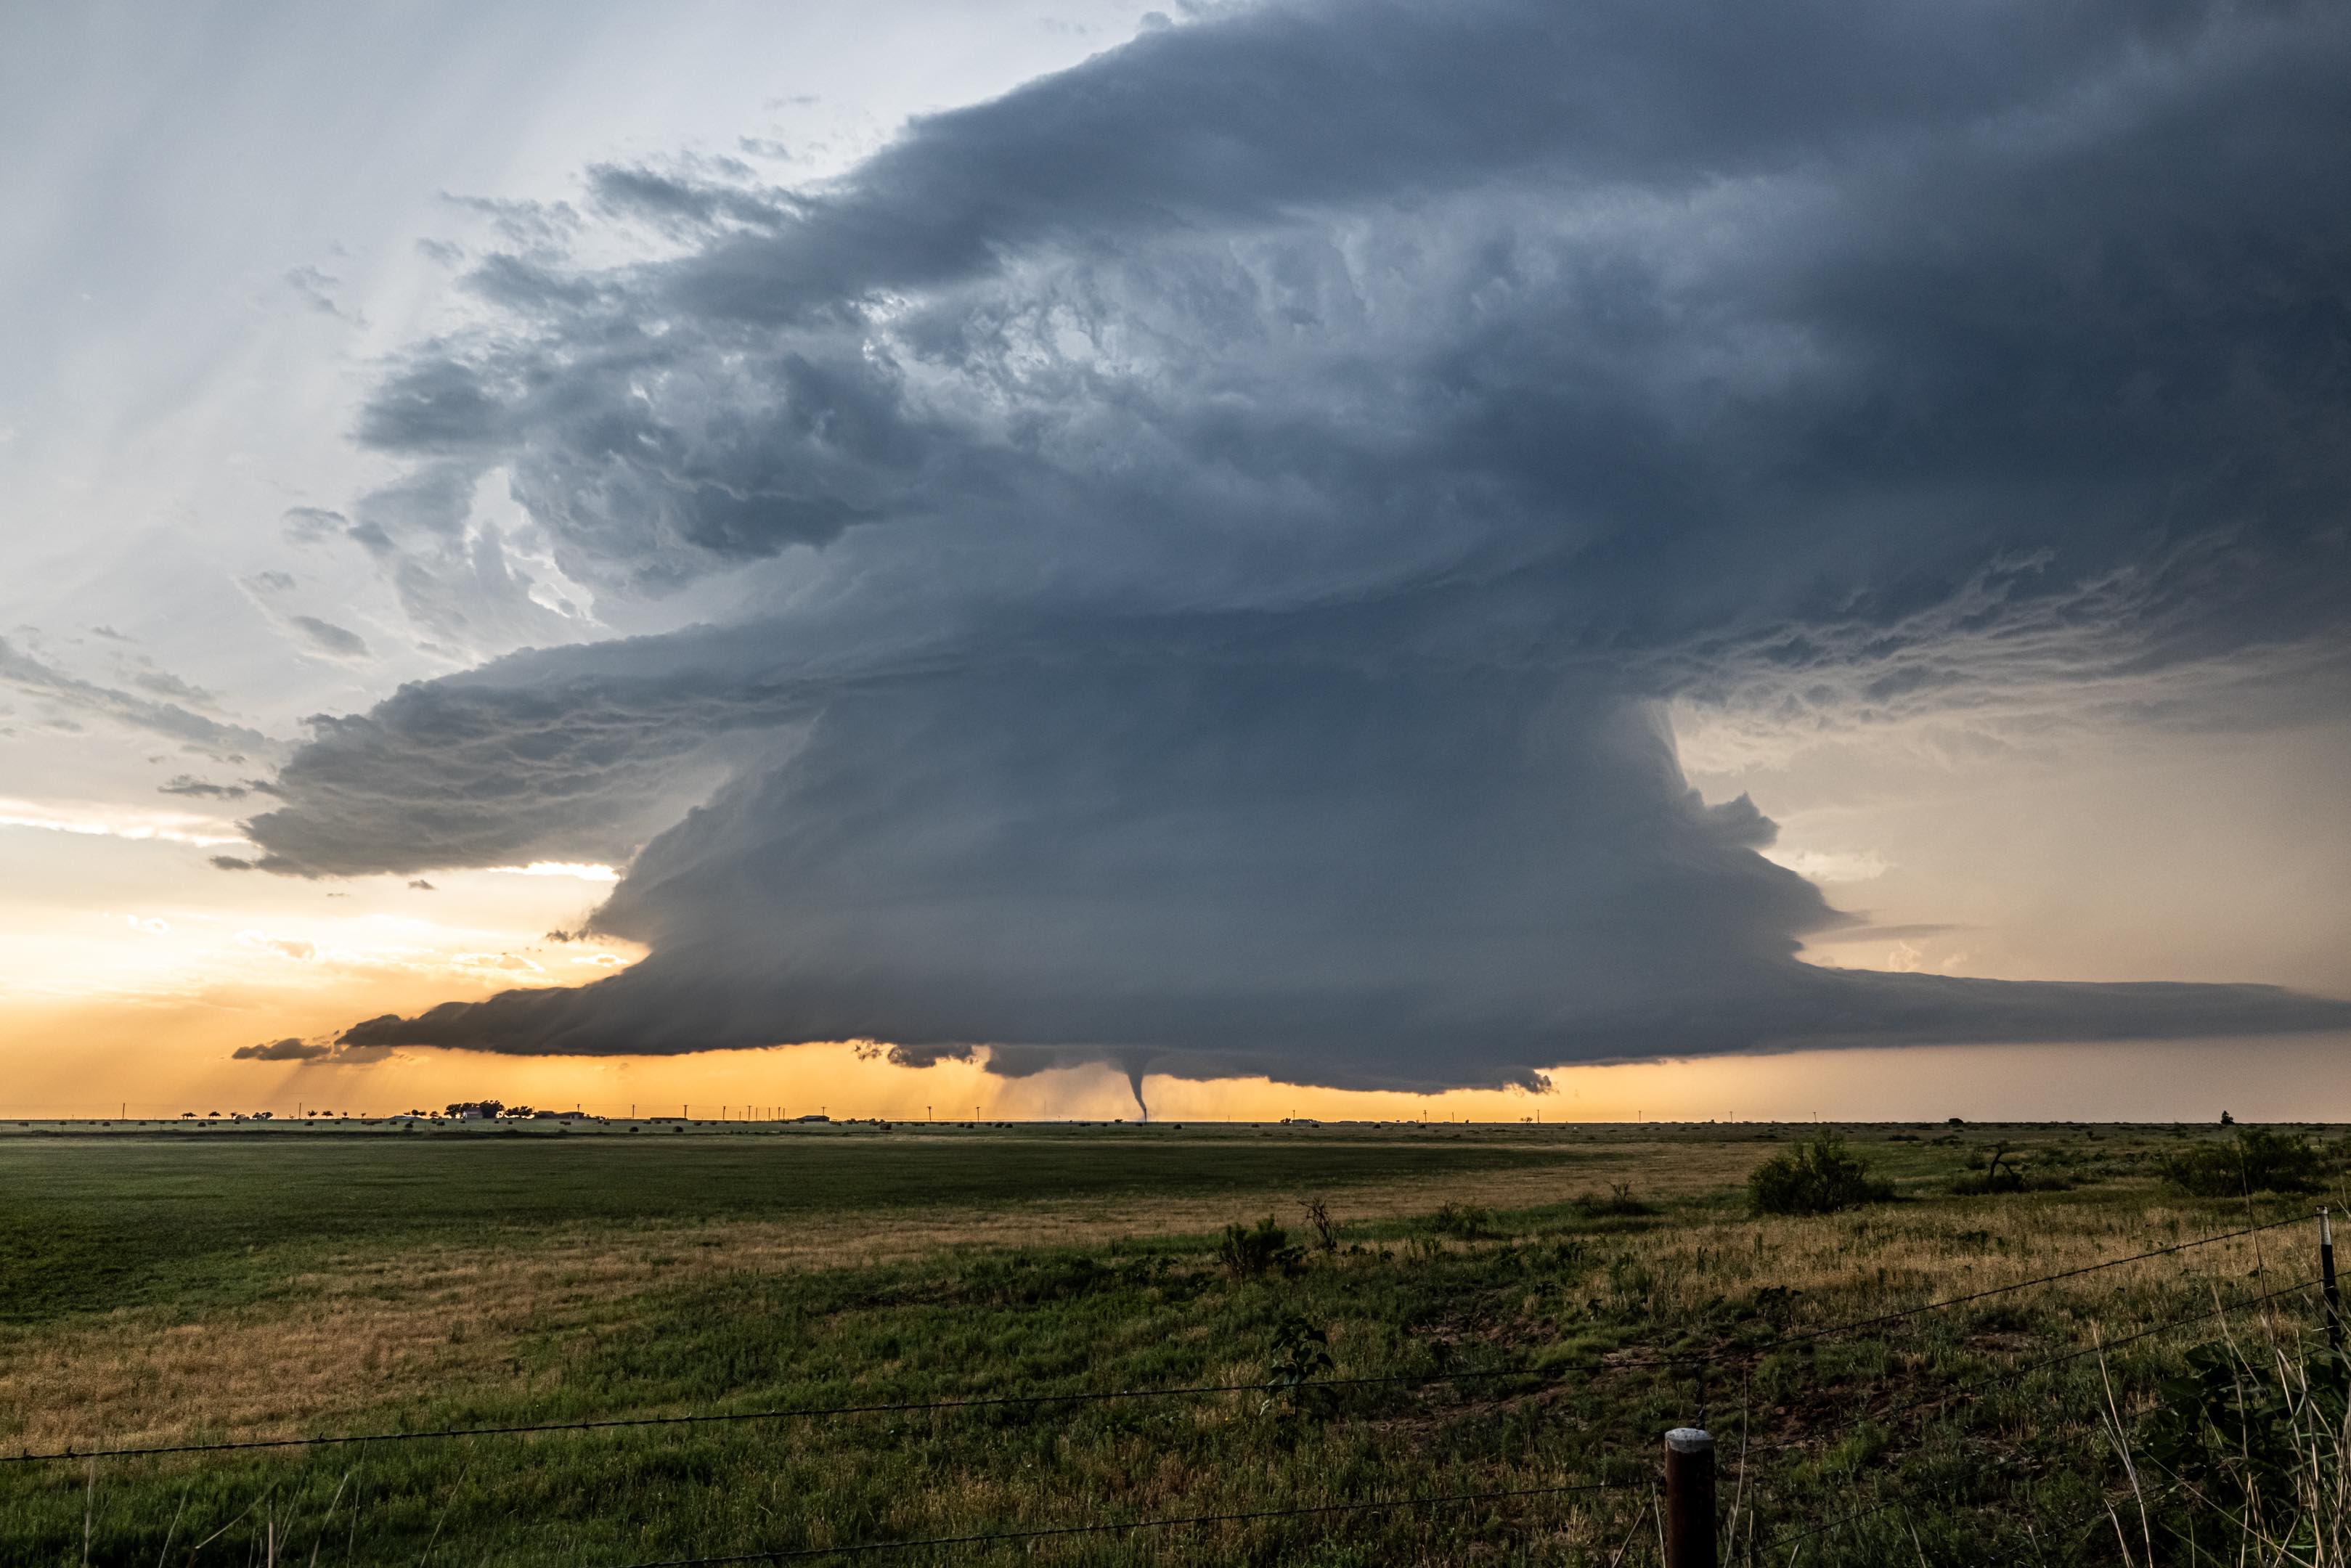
[0,1126,2339,1566]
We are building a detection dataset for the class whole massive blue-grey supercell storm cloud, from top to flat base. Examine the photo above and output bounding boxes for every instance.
[247,2,2351,1086]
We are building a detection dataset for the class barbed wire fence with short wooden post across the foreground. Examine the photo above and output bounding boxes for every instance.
[0,1209,2342,1568]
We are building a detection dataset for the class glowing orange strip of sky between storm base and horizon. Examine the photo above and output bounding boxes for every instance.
[0,1029,2351,1124]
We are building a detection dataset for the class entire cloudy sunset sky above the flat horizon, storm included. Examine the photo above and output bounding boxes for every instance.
[0,0,2351,1122]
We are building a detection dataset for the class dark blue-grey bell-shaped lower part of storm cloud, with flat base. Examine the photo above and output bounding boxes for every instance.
[327,628,2351,1088]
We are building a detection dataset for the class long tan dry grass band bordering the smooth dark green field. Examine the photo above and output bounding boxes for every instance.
[0,1145,1754,1448]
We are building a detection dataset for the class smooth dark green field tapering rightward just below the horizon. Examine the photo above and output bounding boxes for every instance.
[0,1128,1575,1323]
